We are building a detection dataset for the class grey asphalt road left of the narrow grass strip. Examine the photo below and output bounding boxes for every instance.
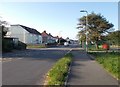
[2,48,70,85]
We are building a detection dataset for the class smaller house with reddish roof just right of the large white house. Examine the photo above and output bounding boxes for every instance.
[41,31,56,43]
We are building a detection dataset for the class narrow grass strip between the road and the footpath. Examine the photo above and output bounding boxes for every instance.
[45,53,73,86]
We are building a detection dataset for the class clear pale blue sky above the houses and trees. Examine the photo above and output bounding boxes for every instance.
[0,2,118,39]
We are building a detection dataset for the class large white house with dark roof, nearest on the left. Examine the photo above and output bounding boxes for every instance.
[7,24,42,44]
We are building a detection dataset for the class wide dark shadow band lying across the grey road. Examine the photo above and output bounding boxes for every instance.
[2,49,68,59]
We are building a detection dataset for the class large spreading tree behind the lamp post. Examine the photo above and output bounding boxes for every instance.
[77,12,114,48]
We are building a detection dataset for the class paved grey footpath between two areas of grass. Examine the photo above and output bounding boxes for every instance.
[67,50,118,85]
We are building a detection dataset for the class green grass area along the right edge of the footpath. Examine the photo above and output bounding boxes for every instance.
[90,52,120,79]
